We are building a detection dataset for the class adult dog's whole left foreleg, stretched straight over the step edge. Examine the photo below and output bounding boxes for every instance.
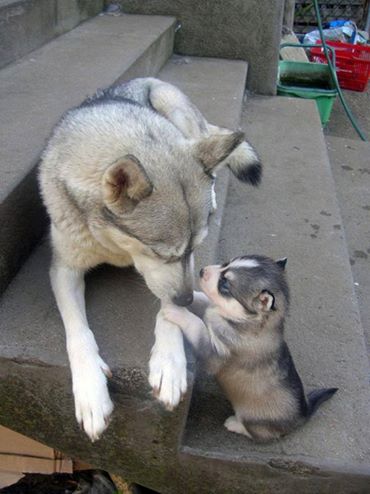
[50,261,113,441]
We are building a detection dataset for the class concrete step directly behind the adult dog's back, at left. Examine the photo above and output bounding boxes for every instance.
[0,15,175,293]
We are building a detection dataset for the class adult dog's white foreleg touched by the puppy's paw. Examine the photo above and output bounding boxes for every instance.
[149,311,186,410]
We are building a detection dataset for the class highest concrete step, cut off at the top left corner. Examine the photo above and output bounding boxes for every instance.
[0,0,104,68]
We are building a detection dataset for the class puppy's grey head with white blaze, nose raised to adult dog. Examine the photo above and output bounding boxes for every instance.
[200,256,289,322]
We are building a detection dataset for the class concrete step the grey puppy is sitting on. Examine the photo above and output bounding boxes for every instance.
[181,97,370,494]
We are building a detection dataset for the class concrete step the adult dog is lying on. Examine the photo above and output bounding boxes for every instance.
[0,57,247,492]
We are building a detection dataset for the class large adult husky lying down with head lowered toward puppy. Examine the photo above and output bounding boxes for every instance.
[40,78,261,440]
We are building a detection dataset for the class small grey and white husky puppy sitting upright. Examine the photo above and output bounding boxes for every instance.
[162,256,337,442]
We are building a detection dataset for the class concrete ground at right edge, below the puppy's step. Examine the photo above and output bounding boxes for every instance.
[324,84,370,356]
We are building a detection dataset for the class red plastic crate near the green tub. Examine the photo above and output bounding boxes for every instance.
[310,41,370,91]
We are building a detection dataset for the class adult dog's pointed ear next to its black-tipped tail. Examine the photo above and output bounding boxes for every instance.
[195,132,244,173]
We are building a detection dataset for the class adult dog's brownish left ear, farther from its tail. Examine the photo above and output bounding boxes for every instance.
[102,154,153,213]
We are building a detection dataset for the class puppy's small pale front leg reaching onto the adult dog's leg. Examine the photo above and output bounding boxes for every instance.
[162,305,213,359]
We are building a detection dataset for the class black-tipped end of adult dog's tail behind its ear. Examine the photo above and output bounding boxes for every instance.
[227,141,262,185]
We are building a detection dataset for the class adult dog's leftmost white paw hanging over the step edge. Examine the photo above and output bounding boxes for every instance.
[72,352,113,442]
